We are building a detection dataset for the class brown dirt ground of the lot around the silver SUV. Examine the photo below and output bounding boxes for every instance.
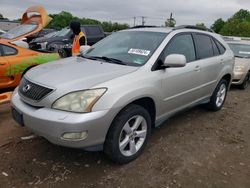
[0,88,250,188]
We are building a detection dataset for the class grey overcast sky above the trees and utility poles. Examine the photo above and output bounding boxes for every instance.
[0,0,250,26]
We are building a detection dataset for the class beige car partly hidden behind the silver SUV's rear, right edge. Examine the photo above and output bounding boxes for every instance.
[224,37,250,89]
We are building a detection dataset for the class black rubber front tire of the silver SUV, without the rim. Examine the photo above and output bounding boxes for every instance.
[104,104,151,164]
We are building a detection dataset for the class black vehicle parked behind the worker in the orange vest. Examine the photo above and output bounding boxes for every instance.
[29,25,106,57]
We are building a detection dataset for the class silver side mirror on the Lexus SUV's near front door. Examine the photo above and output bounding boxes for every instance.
[163,54,187,67]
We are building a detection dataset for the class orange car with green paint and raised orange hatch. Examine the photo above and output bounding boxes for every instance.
[0,6,60,89]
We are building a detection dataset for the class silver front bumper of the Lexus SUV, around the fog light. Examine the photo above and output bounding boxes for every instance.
[12,92,116,148]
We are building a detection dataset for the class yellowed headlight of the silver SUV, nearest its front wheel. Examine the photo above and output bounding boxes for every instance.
[52,88,107,113]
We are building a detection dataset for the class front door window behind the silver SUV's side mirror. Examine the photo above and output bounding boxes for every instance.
[161,34,196,62]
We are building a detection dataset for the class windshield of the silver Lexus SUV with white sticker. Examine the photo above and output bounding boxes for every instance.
[85,31,167,66]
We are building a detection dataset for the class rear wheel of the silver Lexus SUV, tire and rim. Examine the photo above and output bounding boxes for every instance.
[207,79,228,111]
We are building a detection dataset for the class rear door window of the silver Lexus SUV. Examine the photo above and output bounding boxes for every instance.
[195,34,214,59]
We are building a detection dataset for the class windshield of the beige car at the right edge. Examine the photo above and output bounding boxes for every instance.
[229,43,250,58]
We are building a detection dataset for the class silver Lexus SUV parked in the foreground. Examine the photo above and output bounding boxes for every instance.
[12,27,234,163]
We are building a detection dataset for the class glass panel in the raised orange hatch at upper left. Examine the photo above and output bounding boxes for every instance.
[1,24,37,40]
